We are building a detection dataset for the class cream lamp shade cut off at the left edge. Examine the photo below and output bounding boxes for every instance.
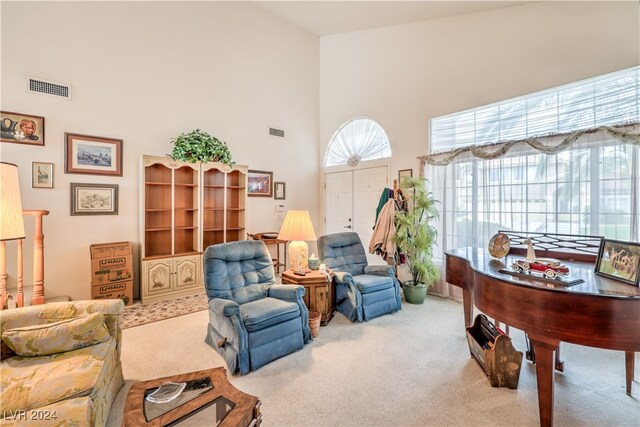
[0,162,25,240]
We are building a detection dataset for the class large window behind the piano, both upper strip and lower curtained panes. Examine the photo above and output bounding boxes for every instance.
[427,67,640,256]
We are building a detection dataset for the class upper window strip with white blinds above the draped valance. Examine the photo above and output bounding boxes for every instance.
[430,67,640,153]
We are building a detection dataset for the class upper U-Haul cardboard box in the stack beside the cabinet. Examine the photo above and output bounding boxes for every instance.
[89,242,133,286]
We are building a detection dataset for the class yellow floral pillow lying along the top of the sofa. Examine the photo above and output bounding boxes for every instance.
[2,313,110,356]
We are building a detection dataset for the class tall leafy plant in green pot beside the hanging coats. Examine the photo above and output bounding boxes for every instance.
[395,177,440,304]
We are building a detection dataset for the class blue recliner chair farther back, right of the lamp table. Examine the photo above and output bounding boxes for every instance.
[318,232,402,322]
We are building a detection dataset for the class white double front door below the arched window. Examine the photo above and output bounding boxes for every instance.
[325,166,388,264]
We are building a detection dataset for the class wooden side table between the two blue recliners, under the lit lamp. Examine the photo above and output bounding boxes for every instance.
[282,270,336,326]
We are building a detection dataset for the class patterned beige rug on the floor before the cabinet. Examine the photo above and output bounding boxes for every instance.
[122,293,208,329]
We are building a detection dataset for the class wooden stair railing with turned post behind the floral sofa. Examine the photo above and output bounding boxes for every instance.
[0,210,49,310]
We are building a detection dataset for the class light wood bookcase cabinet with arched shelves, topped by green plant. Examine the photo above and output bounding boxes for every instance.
[140,156,248,303]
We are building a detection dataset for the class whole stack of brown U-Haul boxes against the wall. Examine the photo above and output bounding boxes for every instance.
[89,242,133,305]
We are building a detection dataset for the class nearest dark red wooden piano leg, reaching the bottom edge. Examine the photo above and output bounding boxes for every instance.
[529,337,559,427]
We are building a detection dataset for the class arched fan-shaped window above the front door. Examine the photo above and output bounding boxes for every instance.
[324,117,391,167]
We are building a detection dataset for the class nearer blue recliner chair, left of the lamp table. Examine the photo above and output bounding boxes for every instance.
[204,240,311,375]
